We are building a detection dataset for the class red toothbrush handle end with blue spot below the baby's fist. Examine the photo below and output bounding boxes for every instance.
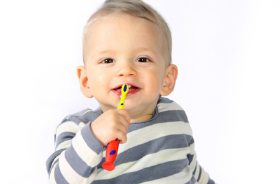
[102,139,120,171]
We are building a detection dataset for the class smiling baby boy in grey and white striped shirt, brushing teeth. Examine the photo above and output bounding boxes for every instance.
[47,0,214,184]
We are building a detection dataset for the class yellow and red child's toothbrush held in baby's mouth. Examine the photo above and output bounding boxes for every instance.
[102,84,129,171]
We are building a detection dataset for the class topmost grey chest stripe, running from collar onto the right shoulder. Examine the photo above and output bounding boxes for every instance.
[128,110,188,132]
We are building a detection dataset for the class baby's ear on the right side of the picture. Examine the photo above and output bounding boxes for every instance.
[160,64,178,96]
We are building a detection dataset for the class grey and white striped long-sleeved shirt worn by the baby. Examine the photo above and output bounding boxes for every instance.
[47,98,214,184]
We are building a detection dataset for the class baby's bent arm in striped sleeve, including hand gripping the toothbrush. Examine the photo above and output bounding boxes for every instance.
[47,109,130,184]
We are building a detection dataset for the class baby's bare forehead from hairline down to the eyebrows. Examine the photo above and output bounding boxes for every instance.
[84,13,166,55]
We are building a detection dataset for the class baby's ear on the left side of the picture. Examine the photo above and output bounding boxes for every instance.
[77,66,93,98]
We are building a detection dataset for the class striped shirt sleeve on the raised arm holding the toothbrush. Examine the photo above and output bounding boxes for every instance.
[47,118,104,184]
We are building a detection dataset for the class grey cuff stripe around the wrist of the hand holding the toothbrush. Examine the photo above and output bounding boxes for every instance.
[81,123,104,154]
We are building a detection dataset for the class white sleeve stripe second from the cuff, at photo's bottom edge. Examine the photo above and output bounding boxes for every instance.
[59,152,86,183]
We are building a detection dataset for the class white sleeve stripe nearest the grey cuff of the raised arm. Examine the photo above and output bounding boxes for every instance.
[72,132,102,167]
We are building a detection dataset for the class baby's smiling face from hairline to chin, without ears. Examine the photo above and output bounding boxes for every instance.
[81,13,173,118]
